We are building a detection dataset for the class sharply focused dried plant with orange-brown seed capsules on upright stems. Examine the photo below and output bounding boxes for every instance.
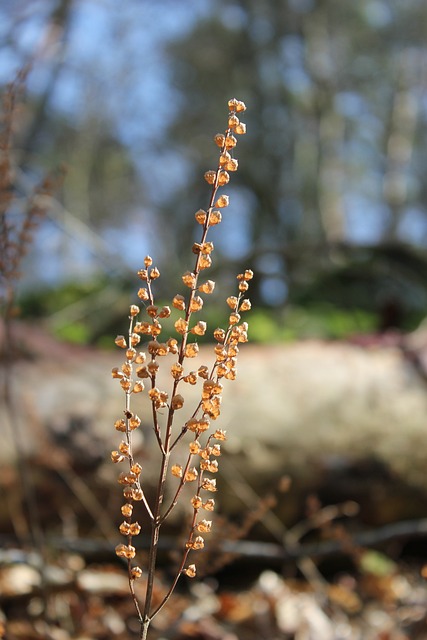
[111,99,253,639]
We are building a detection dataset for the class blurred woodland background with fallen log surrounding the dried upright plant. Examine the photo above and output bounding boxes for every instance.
[0,0,427,640]
